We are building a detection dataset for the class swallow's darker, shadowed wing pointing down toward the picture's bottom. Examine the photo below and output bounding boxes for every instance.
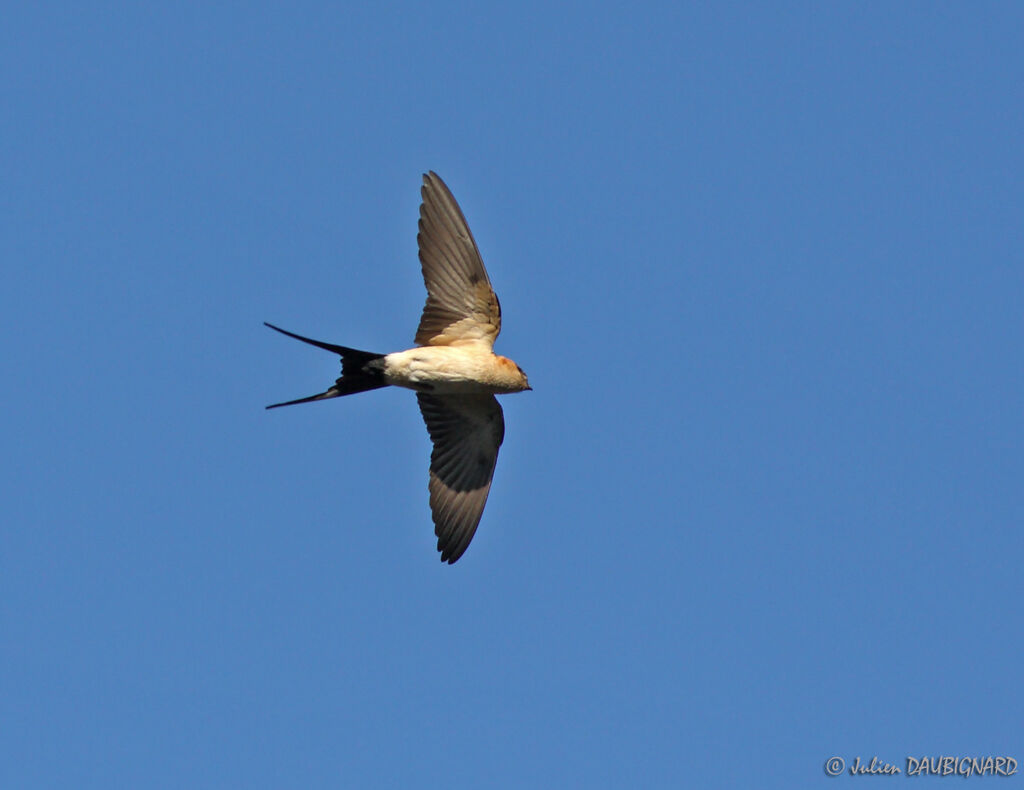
[416,392,505,564]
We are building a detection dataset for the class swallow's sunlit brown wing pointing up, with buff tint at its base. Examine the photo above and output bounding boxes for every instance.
[416,171,502,349]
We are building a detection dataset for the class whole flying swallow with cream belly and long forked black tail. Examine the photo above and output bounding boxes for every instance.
[266,171,531,565]
